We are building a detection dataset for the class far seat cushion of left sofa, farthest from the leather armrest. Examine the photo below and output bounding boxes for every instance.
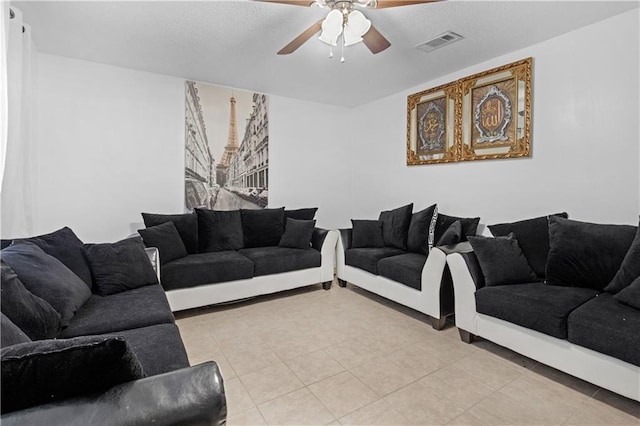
[60,284,174,338]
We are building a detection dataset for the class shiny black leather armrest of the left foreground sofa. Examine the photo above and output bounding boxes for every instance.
[2,361,227,426]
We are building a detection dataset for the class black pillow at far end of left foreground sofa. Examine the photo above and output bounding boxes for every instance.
[86,238,158,296]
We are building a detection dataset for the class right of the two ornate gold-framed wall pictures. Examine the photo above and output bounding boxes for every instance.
[457,58,532,161]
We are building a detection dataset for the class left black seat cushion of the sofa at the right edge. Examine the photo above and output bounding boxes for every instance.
[475,283,598,339]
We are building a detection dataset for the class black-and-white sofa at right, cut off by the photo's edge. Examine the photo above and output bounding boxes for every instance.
[447,213,640,401]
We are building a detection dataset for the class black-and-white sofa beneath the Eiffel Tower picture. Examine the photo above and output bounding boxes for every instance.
[138,207,338,311]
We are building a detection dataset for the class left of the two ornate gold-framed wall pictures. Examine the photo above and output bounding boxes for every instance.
[407,83,458,165]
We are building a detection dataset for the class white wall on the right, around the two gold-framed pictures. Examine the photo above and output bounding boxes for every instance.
[348,9,640,228]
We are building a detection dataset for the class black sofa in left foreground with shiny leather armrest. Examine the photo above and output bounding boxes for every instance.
[0,228,226,425]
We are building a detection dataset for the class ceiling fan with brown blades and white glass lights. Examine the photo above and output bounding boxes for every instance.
[256,0,440,57]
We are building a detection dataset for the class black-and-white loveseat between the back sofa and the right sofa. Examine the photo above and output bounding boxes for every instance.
[336,204,480,330]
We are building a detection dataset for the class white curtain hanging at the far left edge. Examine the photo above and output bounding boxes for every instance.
[0,2,35,238]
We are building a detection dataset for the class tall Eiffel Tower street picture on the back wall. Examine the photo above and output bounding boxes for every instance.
[184,81,269,212]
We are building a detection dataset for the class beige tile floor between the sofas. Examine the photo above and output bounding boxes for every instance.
[177,284,640,425]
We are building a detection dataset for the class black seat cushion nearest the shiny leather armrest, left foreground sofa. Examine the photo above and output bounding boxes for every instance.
[103,324,189,376]
